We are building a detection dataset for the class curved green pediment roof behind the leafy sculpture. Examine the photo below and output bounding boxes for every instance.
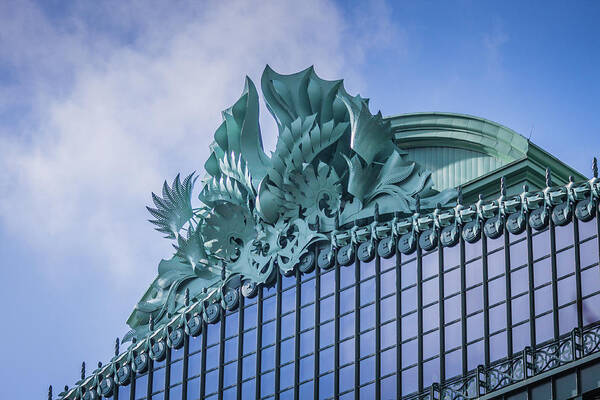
[385,112,584,201]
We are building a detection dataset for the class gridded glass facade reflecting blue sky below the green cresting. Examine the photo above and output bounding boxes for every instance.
[86,211,600,400]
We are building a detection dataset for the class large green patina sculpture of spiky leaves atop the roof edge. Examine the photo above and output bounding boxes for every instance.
[128,66,456,337]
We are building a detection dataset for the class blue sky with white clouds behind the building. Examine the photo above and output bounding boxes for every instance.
[0,0,600,399]
